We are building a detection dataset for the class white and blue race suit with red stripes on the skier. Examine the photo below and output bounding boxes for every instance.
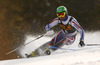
[46,15,84,45]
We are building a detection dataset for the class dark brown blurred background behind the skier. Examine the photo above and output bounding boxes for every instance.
[0,0,100,60]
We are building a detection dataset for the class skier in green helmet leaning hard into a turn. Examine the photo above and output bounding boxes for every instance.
[26,6,85,57]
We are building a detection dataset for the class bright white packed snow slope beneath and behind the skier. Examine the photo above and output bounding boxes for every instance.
[0,31,100,65]
